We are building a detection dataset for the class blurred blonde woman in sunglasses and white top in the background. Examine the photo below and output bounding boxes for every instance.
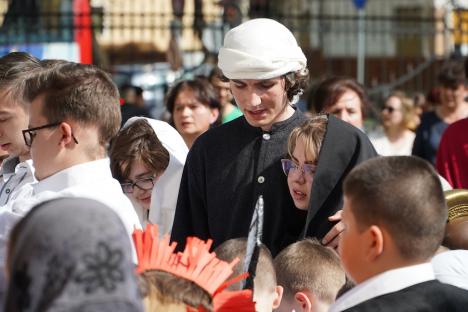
[369,91,417,156]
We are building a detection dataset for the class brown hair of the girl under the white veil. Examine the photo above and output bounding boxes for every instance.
[109,119,170,182]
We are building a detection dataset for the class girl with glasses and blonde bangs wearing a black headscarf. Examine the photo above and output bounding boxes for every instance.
[281,115,377,248]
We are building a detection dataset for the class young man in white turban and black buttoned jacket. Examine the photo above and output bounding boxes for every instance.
[172,19,344,254]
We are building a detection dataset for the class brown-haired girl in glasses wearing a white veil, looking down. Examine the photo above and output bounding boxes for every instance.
[110,117,188,233]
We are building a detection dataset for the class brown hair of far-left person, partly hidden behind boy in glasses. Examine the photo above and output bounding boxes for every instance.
[0,52,41,109]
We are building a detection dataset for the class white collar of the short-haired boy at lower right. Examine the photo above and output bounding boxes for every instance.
[330,263,435,312]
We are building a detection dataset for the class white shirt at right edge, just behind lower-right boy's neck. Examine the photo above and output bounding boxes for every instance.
[431,250,468,290]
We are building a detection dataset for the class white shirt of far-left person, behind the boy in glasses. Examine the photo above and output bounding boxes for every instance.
[0,157,37,206]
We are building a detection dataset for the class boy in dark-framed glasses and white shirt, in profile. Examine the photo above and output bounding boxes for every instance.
[0,61,140,268]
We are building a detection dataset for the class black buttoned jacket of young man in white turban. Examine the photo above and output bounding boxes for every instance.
[171,110,306,255]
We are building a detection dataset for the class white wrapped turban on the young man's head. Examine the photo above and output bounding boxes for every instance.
[218,18,307,79]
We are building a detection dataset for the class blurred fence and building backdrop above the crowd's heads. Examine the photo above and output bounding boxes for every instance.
[0,0,468,115]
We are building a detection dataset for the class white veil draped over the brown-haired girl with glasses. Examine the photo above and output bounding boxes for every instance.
[123,117,188,234]
